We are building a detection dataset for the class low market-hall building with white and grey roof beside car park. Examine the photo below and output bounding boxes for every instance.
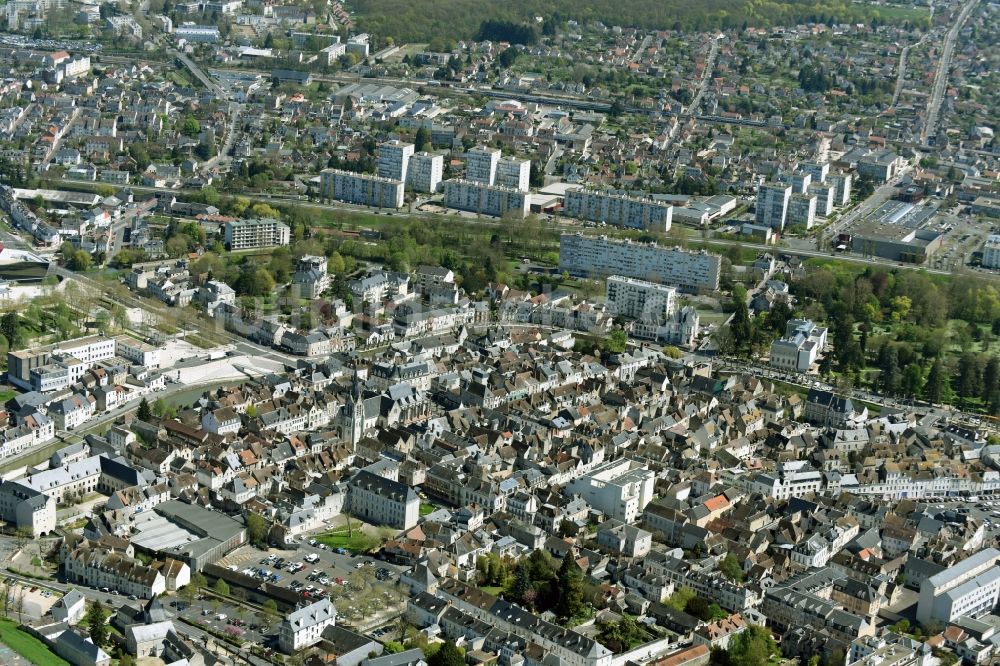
[132,500,246,571]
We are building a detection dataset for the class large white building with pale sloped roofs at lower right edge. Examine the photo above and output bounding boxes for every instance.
[917,548,1000,625]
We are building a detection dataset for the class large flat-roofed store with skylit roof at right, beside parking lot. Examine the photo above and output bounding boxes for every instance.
[851,201,944,264]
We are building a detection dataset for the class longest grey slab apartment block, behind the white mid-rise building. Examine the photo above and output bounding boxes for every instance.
[559,234,722,292]
